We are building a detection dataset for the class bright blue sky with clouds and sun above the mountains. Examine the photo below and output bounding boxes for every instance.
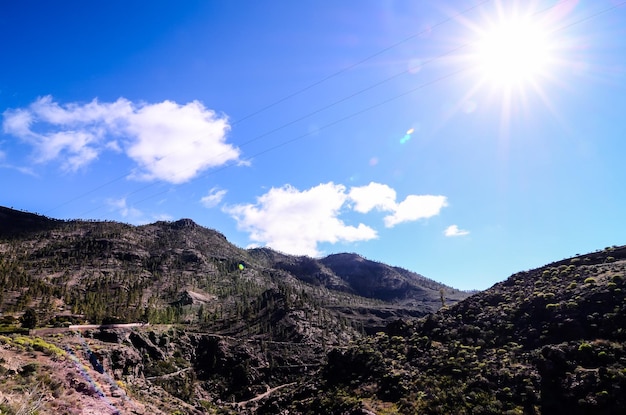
[0,0,626,289]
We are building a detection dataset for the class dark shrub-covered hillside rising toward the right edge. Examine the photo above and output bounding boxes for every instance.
[270,246,626,415]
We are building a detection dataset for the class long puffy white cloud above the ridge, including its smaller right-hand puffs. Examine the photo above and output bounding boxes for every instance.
[224,182,447,256]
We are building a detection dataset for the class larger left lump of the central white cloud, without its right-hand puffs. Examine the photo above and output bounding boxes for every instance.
[224,182,377,256]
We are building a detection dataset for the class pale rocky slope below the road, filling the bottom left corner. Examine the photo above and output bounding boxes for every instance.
[0,325,320,415]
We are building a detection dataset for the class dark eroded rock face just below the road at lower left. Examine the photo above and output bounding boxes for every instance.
[61,327,325,402]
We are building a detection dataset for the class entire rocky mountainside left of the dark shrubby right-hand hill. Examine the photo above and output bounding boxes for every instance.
[0,208,468,414]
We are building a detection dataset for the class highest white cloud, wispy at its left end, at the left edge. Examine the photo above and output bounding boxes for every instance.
[3,96,240,183]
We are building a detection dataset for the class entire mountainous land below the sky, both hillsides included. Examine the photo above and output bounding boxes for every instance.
[0,209,626,415]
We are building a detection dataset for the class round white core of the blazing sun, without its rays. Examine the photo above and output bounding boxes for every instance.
[472,17,553,88]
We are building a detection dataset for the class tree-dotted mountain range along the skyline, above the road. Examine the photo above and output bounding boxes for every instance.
[0,208,468,331]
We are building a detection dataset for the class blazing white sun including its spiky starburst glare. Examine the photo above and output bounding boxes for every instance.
[450,0,576,132]
